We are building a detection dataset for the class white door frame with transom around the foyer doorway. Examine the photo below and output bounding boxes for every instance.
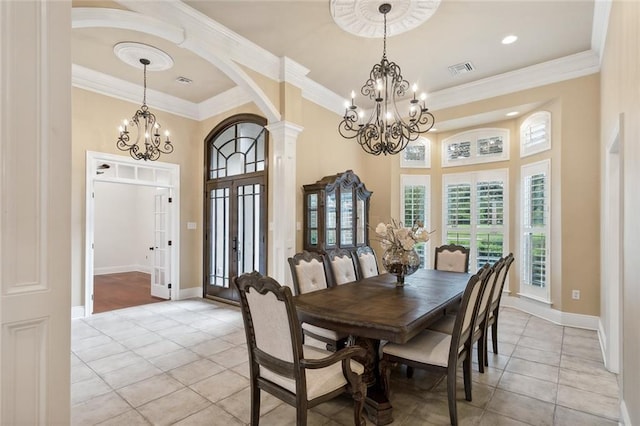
[84,151,180,317]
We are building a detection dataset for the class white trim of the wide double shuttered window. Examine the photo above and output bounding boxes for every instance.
[441,169,509,272]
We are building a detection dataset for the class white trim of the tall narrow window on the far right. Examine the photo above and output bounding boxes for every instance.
[518,159,552,304]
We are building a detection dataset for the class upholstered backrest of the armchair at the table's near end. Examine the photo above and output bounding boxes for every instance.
[236,272,302,380]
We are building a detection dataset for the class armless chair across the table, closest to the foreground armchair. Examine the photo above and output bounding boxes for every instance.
[288,251,349,351]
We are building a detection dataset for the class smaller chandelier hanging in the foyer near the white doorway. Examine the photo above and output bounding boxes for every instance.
[116,58,173,161]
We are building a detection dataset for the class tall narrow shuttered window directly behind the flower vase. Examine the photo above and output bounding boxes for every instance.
[400,175,431,268]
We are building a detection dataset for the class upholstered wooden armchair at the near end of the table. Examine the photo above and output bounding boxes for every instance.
[236,272,366,426]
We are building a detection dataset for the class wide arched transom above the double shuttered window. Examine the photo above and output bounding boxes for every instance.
[442,129,509,167]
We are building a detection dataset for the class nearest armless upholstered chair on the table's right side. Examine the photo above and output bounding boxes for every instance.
[380,268,489,426]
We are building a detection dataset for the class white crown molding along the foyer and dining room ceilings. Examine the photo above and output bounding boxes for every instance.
[72,0,611,120]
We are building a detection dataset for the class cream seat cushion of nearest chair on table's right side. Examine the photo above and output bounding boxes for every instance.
[382,330,451,367]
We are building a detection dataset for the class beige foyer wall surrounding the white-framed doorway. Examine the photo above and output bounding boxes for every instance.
[71,88,203,306]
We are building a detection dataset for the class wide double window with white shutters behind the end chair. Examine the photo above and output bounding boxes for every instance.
[442,170,509,271]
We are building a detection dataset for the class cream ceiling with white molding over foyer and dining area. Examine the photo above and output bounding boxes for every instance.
[72,0,605,128]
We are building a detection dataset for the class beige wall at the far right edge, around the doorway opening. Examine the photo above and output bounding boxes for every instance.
[600,1,640,424]
